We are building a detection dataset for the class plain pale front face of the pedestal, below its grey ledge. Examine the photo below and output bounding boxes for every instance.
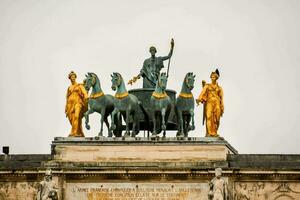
[55,145,228,162]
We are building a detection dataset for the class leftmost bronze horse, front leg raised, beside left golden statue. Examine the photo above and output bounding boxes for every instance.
[84,72,114,137]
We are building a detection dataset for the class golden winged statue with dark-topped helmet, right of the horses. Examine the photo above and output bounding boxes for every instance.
[196,69,224,137]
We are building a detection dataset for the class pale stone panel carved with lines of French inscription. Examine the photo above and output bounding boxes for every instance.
[66,183,209,200]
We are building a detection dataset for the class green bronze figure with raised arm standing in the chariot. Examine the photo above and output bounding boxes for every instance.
[139,39,174,88]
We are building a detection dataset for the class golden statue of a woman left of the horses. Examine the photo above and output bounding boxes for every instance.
[65,71,88,137]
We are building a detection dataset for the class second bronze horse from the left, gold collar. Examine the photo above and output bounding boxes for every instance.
[111,72,140,137]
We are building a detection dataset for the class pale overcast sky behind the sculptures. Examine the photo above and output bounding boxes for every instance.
[0,0,300,154]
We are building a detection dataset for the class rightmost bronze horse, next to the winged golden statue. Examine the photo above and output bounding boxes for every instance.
[175,72,196,137]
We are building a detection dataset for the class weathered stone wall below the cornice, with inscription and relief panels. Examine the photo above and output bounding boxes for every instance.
[0,173,300,200]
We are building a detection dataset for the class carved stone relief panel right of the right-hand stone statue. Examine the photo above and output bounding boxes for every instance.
[234,181,300,200]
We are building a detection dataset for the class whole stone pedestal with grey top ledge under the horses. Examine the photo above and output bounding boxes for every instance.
[52,137,237,163]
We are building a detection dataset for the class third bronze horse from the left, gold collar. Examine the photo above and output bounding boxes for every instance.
[150,73,172,137]
